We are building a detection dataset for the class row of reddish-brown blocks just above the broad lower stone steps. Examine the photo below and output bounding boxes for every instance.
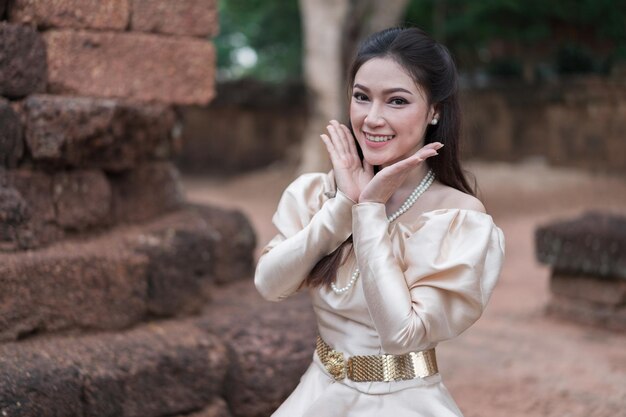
[0,162,185,251]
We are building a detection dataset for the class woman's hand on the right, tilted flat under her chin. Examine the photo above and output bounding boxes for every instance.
[359,142,443,204]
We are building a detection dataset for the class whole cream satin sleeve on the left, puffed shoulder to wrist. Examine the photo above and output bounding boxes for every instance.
[254,173,355,301]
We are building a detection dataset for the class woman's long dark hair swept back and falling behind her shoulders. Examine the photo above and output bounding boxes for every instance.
[304,28,475,287]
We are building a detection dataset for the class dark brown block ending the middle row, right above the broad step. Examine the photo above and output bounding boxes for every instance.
[109,162,185,222]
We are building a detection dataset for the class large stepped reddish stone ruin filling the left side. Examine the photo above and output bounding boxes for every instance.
[0,0,314,417]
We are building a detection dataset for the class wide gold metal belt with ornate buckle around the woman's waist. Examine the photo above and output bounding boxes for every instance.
[315,336,439,382]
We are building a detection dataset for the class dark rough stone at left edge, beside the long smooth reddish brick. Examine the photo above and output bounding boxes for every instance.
[0,22,47,98]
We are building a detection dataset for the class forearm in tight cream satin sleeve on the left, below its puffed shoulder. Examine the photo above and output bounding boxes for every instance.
[254,192,354,301]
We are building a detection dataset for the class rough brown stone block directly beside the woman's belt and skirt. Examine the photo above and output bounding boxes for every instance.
[202,281,317,417]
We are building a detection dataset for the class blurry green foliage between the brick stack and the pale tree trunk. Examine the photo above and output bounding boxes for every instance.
[215,0,302,81]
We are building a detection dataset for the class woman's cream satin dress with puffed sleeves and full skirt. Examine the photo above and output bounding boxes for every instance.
[255,174,504,417]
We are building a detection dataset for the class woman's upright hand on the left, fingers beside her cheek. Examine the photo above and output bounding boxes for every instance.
[320,120,374,202]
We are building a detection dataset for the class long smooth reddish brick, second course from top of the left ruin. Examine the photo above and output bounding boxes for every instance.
[44,30,215,104]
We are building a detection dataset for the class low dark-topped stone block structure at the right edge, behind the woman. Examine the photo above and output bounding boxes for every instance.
[535,212,626,331]
